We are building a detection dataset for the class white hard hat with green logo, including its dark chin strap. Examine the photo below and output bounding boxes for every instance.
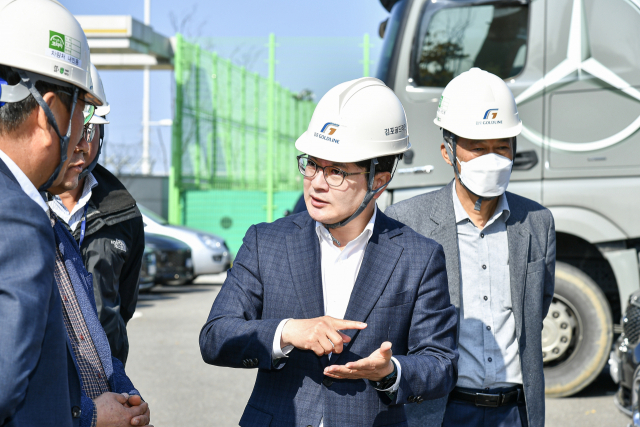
[0,0,104,190]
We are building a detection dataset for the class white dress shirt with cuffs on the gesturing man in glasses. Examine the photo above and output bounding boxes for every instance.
[272,206,402,427]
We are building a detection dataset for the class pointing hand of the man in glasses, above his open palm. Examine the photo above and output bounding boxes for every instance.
[280,316,367,356]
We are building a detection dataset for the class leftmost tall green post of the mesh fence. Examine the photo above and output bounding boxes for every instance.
[168,34,184,224]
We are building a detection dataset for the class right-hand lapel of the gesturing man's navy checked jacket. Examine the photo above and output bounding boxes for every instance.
[332,210,403,363]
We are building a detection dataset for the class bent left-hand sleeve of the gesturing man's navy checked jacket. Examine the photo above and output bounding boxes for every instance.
[200,225,283,369]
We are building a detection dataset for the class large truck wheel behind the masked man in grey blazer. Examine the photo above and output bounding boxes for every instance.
[542,262,613,397]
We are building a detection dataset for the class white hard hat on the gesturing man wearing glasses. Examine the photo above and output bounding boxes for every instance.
[296,77,411,163]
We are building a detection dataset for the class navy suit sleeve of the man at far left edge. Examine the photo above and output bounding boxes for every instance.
[0,201,55,424]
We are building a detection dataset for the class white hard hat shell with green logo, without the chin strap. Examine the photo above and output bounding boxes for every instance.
[0,0,103,106]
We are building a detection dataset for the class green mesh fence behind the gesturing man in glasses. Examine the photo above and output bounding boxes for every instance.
[169,35,378,251]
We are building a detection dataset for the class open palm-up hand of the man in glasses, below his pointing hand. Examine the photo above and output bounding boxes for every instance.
[324,341,393,381]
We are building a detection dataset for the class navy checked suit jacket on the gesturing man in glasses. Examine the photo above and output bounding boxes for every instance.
[200,211,458,427]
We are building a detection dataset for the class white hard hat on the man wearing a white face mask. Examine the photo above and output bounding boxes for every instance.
[433,68,522,139]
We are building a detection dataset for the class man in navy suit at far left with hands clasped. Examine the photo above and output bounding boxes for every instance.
[0,0,149,426]
